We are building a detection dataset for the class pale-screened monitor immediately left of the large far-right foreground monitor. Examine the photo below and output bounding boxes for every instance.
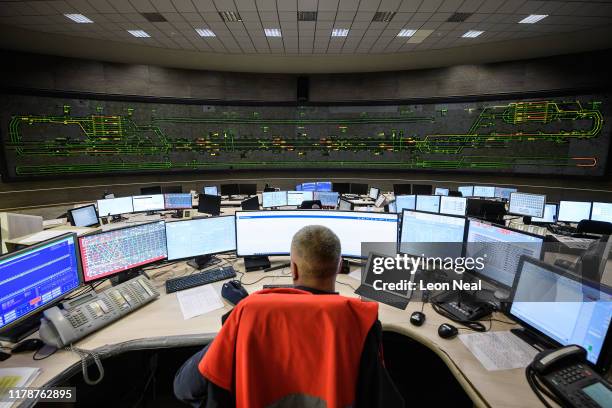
[466,219,543,289]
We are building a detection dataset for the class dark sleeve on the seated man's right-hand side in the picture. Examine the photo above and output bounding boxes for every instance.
[355,320,405,408]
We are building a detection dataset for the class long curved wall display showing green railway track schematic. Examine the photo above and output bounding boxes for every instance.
[0,95,611,179]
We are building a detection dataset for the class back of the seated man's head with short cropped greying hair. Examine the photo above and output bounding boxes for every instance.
[291,225,341,280]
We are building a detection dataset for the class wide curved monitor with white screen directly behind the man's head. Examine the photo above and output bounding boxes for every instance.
[236,210,397,258]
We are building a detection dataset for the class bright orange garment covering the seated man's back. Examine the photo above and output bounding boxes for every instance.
[200,289,378,408]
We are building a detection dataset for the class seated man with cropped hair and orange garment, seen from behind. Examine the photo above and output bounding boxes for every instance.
[174,226,404,408]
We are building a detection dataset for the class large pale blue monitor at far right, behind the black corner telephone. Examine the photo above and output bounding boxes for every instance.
[507,257,612,372]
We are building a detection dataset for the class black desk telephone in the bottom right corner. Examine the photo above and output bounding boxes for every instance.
[526,345,612,408]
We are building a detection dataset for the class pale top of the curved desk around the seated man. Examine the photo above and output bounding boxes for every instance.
[2,256,542,407]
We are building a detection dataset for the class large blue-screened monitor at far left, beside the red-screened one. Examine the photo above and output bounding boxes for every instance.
[0,234,81,335]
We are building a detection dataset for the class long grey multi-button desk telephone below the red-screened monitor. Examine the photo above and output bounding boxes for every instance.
[39,276,159,348]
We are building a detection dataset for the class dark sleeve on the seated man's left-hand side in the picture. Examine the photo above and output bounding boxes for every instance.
[174,342,235,408]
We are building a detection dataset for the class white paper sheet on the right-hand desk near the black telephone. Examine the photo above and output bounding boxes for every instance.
[459,331,538,371]
